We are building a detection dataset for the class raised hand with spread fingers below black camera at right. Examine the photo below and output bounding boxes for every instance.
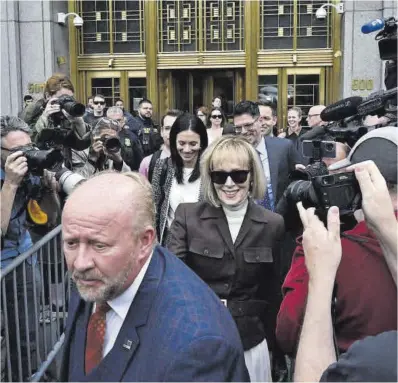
[297,202,342,281]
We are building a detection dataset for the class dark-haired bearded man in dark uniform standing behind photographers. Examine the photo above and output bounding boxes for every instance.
[129,99,163,157]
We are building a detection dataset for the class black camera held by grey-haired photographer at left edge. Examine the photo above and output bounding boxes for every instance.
[18,146,64,176]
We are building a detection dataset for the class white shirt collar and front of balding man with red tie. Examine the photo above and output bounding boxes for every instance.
[97,253,153,358]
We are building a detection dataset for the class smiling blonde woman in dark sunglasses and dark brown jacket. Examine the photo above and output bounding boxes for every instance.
[169,135,284,382]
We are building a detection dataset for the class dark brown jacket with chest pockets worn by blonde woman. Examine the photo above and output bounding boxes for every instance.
[169,201,284,350]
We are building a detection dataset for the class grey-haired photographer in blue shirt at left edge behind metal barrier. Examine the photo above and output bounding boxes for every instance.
[0,116,59,380]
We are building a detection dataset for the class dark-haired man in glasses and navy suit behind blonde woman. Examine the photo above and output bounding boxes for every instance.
[234,101,301,210]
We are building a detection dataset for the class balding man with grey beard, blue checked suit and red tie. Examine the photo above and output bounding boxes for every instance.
[60,173,249,382]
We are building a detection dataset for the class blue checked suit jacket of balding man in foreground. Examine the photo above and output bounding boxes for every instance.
[60,246,249,382]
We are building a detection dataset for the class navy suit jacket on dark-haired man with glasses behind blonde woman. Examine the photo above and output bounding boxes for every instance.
[265,136,302,206]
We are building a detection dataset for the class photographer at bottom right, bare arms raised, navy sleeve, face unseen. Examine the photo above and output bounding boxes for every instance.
[295,200,397,382]
